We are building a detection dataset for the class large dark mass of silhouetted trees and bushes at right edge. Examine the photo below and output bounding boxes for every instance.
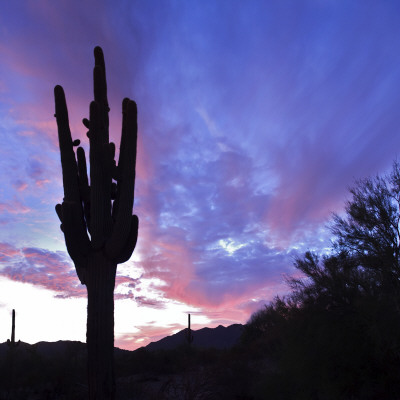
[243,163,400,399]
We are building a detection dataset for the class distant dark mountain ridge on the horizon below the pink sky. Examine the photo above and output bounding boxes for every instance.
[144,324,243,351]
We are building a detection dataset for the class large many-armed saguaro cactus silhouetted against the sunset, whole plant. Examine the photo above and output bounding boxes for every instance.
[54,47,139,400]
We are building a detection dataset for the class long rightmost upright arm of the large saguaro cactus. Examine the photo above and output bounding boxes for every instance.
[105,99,137,259]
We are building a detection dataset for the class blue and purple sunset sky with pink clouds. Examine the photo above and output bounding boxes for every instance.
[0,0,400,350]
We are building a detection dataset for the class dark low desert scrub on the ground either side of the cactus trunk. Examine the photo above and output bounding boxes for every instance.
[0,342,252,400]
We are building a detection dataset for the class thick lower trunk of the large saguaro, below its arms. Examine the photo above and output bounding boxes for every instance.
[86,252,117,400]
